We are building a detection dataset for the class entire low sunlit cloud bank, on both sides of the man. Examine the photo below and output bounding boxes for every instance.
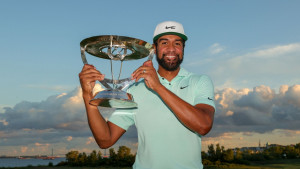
[0,82,300,154]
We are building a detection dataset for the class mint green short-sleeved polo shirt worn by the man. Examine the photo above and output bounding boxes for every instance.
[109,68,215,169]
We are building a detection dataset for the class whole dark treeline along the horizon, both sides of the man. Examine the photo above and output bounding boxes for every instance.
[58,143,300,167]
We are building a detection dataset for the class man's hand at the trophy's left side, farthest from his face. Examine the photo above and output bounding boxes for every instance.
[79,64,105,97]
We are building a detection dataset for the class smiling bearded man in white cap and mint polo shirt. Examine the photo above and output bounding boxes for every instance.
[79,21,215,169]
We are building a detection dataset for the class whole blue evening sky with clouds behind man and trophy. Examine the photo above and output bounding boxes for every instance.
[0,0,300,155]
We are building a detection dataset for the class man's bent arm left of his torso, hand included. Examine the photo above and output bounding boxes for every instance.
[79,64,126,148]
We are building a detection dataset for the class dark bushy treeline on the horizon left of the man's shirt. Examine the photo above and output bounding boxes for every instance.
[58,146,135,167]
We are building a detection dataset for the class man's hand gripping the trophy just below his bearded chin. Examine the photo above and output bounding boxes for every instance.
[131,60,161,91]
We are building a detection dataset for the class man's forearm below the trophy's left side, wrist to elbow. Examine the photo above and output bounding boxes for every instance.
[83,94,112,148]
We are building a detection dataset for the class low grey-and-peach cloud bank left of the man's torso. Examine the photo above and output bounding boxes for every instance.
[0,84,136,154]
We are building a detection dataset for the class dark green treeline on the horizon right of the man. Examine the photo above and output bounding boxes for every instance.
[202,143,300,165]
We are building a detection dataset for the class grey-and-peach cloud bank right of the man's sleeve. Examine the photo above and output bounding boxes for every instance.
[210,85,300,136]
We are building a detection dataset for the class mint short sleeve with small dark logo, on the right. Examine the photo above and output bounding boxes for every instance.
[194,75,216,109]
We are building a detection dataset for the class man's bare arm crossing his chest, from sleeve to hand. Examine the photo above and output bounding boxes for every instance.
[132,61,215,135]
